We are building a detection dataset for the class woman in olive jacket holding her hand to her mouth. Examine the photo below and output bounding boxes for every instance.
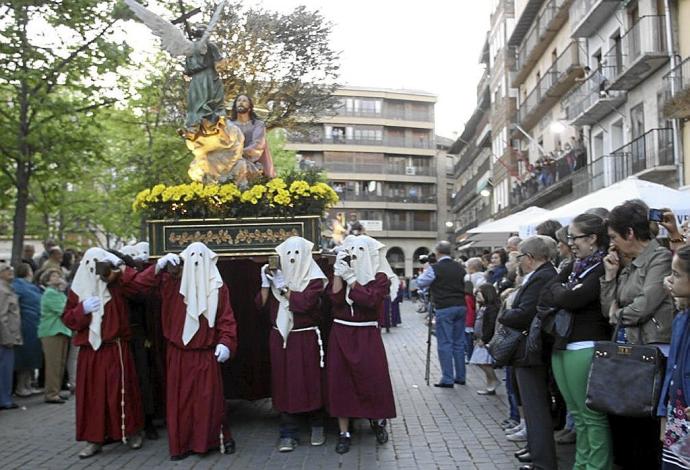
[600,201,674,469]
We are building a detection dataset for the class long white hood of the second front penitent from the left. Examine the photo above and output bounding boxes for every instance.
[180,242,223,345]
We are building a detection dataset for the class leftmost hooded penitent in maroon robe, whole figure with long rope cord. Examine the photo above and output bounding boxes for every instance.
[62,248,144,459]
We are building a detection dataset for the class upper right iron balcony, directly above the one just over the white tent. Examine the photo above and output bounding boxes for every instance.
[602,16,669,90]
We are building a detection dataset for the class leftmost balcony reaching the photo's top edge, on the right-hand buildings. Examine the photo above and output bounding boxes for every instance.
[512,0,572,88]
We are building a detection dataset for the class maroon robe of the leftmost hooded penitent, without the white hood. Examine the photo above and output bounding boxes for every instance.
[62,268,144,444]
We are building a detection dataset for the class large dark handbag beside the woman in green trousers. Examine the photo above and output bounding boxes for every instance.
[585,320,666,418]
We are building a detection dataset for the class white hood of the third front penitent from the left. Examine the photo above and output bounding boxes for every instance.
[272,237,328,347]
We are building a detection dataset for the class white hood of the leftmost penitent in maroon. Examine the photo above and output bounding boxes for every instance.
[72,248,122,350]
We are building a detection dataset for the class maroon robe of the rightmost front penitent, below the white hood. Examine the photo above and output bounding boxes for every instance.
[326,273,395,419]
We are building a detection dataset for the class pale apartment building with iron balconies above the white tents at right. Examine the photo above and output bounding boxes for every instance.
[453,0,690,248]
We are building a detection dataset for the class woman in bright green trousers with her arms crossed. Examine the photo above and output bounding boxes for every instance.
[542,214,613,470]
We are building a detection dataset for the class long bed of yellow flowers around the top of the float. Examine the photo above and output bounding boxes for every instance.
[132,178,338,218]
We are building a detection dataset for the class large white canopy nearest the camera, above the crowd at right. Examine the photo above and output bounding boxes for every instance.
[519,177,690,238]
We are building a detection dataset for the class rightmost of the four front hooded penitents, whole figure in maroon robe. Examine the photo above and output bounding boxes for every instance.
[327,235,398,454]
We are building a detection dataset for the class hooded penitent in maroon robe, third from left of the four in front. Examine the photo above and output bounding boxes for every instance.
[260,237,328,452]
